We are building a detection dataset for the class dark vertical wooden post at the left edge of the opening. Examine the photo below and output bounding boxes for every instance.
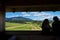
[0,4,5,32]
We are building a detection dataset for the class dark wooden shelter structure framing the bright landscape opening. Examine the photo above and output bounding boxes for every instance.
[0,0,60,40]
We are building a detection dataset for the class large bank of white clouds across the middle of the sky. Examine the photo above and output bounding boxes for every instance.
[22,12,54,20]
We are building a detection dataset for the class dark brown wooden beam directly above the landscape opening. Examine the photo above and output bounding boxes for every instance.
[6,5,60,12]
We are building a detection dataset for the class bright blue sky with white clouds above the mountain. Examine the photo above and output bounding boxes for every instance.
[5,11,60,20]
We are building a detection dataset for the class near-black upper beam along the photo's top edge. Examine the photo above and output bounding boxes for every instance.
[5,0,60,5]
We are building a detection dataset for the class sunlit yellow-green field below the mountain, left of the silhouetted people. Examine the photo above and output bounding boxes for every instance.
[5,22,42,31]
